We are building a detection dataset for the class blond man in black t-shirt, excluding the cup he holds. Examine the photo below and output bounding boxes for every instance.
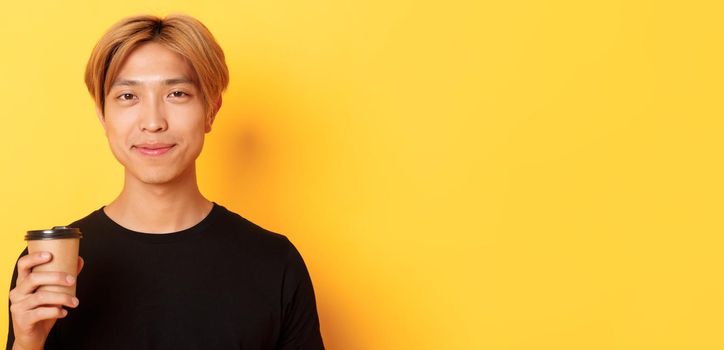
[7,15,324,350]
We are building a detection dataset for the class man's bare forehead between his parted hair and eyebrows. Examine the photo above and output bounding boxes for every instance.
[113,42,195,84]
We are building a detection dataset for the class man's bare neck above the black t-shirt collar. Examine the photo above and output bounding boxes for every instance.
[104,167,213,233]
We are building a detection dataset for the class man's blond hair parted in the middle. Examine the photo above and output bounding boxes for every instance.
[85,14,229,116]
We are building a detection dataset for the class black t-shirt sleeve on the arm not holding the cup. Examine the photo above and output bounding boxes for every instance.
[277,242,324,350]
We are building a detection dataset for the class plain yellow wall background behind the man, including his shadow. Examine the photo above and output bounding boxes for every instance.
[0,0,724,349]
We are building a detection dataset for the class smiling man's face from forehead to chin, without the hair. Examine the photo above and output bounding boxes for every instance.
[98,42,213,184]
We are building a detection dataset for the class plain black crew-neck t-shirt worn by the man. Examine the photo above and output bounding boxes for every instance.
[8,203,324,349]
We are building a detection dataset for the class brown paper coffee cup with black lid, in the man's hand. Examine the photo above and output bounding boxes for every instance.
[25,226,83,296]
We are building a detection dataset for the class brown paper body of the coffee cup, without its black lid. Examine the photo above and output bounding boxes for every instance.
[27,238,80,296]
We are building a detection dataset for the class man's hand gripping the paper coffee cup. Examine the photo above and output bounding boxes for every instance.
[10,252,83,350]
